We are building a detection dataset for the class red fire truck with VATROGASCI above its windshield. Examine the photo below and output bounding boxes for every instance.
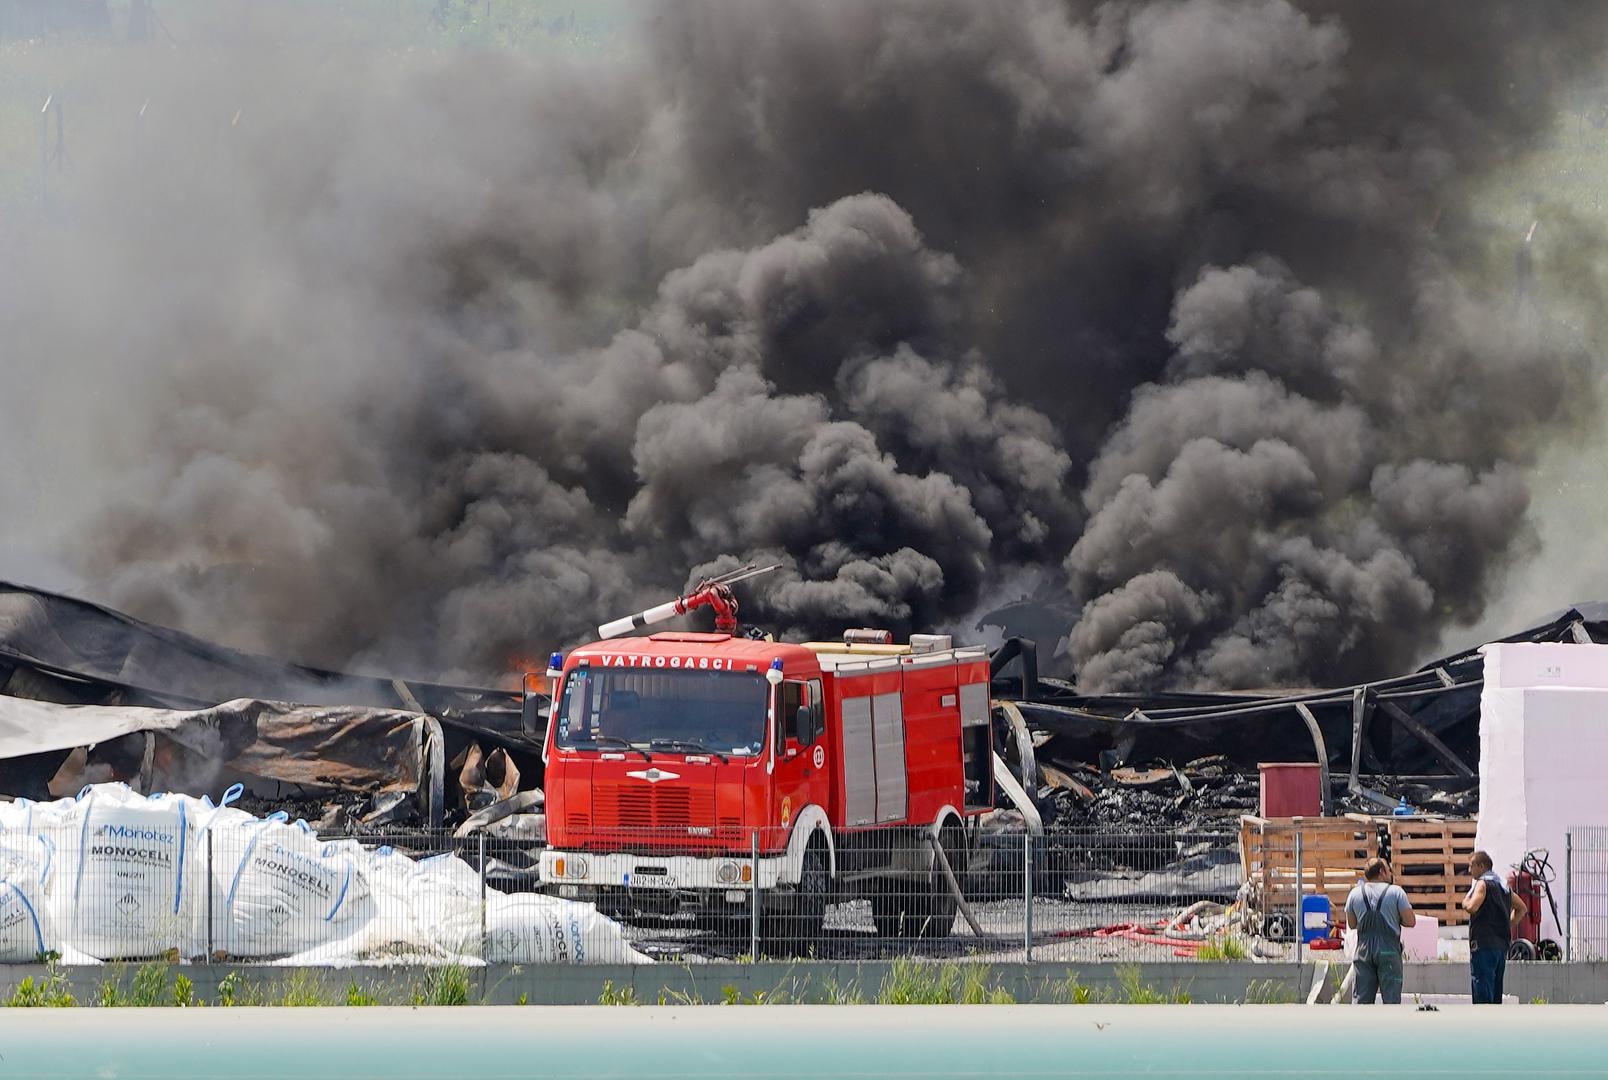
[526,567,995,942]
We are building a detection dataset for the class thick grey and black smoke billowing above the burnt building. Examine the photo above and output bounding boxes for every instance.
[0,0,1608,691]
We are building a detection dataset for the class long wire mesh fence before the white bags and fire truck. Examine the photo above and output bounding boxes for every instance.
[9,824,1318,964]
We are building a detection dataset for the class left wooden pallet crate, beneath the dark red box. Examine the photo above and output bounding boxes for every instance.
[1240,815,1380,911]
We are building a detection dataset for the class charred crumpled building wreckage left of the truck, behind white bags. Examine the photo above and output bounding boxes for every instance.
[0,582,545,831]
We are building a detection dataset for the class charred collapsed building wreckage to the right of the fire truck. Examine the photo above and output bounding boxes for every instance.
[994,603,1608,829]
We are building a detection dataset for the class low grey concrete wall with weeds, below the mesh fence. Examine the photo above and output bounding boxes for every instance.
[0,961,1608,1004]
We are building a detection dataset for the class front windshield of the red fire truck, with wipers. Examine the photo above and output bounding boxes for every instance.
[553,667,770,757]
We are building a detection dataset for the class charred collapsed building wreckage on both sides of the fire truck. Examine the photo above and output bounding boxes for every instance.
[0,582,1608,874]
